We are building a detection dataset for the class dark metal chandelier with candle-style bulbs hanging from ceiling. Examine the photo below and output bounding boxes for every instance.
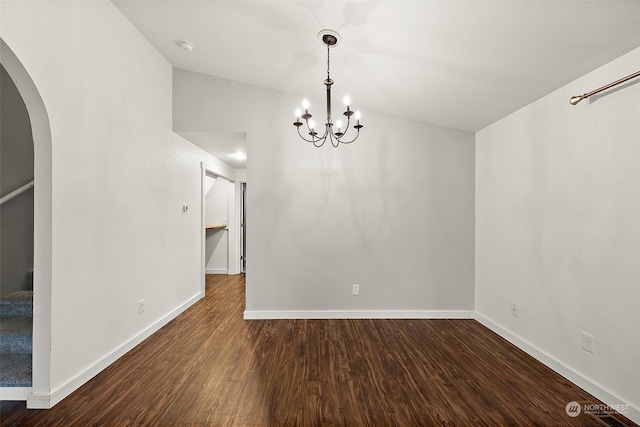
[293,30,363,147]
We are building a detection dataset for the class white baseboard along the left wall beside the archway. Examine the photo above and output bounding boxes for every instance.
[27,293,204,409]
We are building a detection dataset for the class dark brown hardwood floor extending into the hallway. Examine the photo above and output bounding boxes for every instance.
[0,275,633,427]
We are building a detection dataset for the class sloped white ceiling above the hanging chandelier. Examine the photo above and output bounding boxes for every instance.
[114,0,640,162]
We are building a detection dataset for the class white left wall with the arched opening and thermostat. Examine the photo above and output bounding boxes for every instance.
[0,1,233,407]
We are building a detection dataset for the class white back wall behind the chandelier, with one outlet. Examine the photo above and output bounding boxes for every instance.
[174,70,474,317]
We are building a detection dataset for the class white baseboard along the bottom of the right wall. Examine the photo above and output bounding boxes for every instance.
[475,313,640,424]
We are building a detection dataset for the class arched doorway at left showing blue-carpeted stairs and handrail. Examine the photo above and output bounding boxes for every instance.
[0,59,34,400]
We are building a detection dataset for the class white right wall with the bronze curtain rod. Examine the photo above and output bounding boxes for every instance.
[476,49,640,422]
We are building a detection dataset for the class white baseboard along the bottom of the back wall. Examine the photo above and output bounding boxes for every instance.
[244,310,475,320]
